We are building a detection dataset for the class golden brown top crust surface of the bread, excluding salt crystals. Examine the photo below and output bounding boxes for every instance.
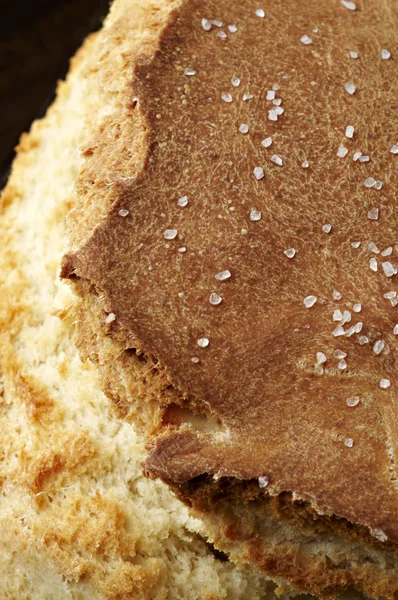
[63,0,398,595]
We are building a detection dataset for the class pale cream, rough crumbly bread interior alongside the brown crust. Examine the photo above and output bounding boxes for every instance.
[0,1,274,600]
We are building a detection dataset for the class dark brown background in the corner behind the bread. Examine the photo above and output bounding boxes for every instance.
[0,0,109,181]
